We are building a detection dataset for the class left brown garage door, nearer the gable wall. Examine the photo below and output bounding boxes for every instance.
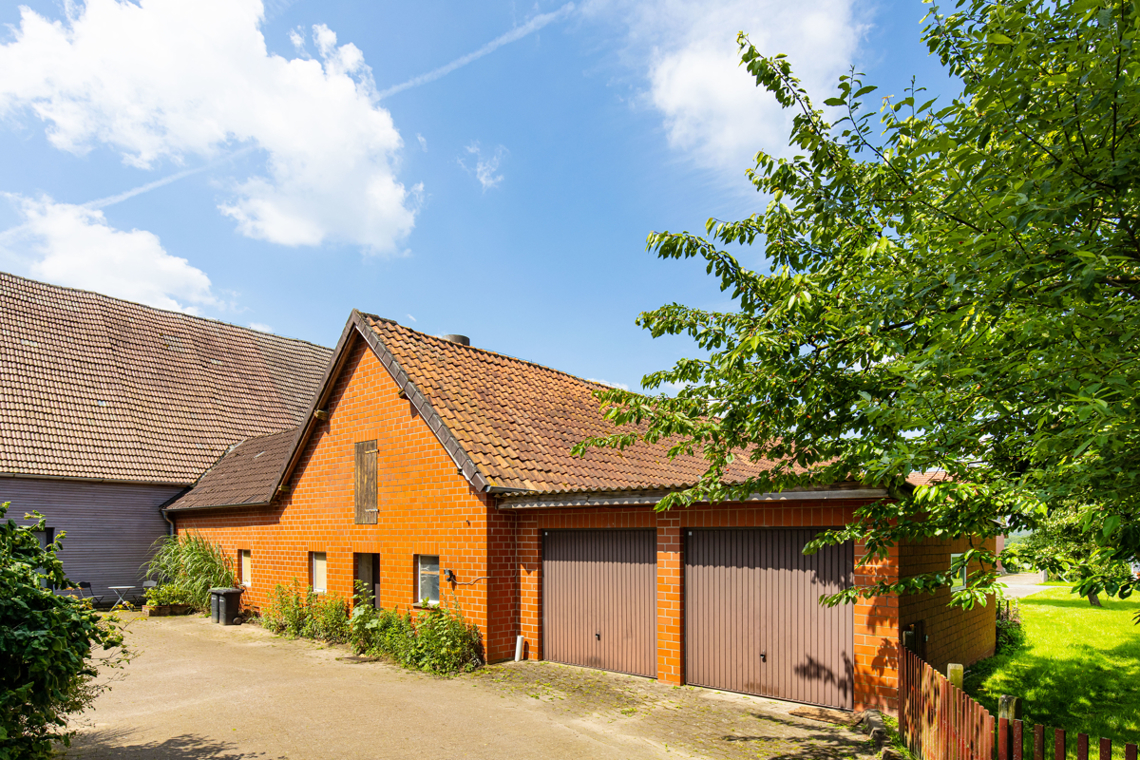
[543,530,657,676]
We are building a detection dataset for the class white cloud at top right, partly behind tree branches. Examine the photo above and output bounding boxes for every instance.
[583,0,865,176]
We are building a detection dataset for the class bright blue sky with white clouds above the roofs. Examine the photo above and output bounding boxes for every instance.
[0,0,953,387]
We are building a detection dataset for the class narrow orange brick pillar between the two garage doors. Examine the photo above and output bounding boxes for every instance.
[657,513,685,685]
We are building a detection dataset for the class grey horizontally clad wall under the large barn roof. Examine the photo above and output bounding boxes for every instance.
[0,477,184,602]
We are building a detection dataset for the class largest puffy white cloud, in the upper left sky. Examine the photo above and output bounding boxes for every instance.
[0,0,416,252]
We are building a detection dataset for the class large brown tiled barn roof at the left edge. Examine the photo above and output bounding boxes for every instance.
[0,273,332,483]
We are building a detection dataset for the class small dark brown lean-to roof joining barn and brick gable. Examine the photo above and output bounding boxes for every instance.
[166,428,296,509]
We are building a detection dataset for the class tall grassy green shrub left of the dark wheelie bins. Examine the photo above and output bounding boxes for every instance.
[144,533,237,612]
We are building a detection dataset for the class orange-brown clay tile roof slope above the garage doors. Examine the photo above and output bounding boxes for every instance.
[363,314,765,492]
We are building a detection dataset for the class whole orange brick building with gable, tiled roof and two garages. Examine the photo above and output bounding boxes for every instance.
[166,311,994,711]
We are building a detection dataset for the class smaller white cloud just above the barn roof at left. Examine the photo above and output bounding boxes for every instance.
[0,195,222,313]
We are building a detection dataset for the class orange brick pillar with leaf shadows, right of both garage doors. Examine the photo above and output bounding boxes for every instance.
[855,544,899,714]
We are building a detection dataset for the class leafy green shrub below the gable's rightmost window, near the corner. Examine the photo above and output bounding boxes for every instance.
[349,586,483,675]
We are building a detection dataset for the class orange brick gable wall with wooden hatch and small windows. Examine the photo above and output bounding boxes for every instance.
[174,337,518,661]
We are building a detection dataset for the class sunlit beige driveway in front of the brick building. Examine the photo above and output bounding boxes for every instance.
[64,616,872,760]
